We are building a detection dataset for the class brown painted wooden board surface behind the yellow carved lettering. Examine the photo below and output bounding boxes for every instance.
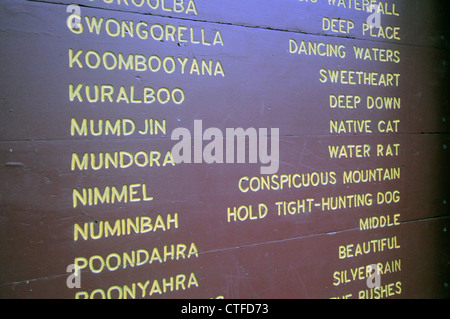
[0,0,450,298]
